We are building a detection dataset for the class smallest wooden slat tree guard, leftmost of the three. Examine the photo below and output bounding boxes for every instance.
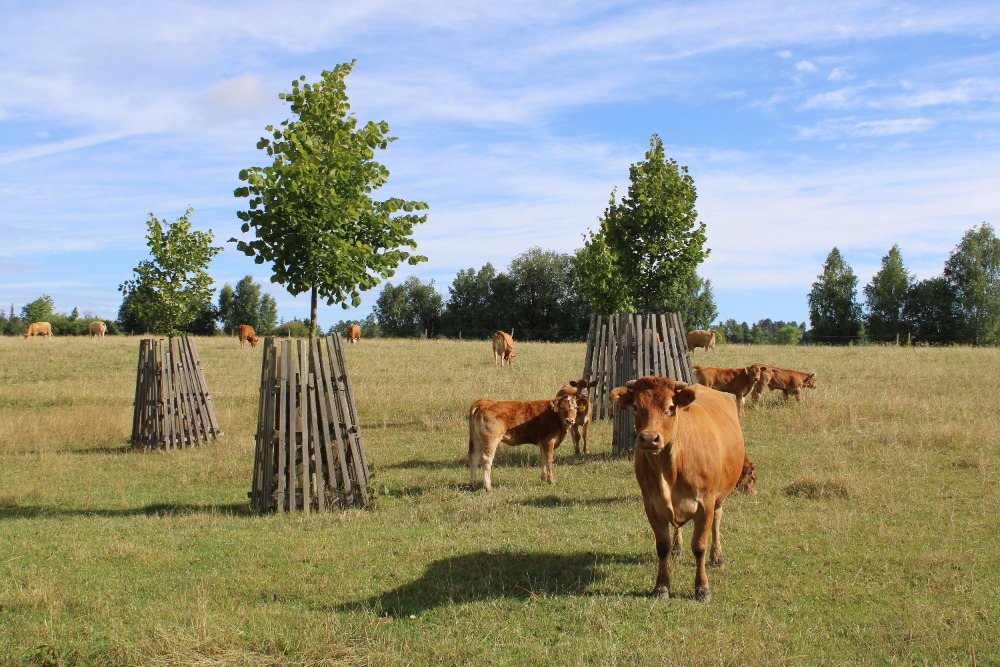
[132,336,222,449]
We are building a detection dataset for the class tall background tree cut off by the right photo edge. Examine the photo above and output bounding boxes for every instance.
[944,222,1000,345]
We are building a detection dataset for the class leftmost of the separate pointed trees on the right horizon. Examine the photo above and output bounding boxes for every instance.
[808,248,861,345]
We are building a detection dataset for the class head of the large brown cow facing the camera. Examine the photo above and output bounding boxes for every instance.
[611,375,695,454]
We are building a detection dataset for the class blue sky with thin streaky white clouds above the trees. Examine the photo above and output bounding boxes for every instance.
[0,0,1000,326]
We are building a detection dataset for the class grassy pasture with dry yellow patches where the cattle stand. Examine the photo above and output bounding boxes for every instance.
[0,337,1000,665]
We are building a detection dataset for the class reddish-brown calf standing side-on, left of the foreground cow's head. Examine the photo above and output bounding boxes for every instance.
[469,394,577,491]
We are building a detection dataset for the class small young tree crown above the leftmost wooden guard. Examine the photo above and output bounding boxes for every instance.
[118,208,222,334]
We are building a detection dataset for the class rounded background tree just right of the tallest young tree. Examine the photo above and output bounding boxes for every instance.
[372,276,444,338]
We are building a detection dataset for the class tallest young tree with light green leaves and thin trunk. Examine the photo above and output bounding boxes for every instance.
[231,61,427,335]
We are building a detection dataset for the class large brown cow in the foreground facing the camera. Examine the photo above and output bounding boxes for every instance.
[611,376,746,601]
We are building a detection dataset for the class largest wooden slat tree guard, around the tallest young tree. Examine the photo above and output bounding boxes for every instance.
[249,333,369,514]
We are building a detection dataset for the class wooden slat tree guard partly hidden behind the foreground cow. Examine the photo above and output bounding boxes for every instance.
[583,313,694,456]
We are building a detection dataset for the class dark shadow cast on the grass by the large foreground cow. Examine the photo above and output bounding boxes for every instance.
[334,551,649,618]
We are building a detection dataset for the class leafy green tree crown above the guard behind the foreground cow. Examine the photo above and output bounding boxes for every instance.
[577,134,709,314]
